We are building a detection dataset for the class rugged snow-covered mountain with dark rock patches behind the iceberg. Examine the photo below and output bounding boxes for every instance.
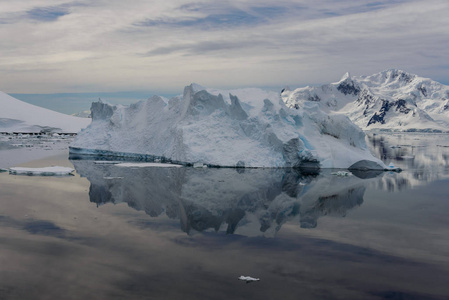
[281,69,449,132]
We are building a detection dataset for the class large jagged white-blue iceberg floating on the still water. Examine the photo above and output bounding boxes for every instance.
[70,85,386,169]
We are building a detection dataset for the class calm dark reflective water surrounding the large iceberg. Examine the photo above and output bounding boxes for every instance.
[0,134,449,299]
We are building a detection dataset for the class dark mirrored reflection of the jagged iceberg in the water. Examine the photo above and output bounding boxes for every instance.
[72,160,377,236]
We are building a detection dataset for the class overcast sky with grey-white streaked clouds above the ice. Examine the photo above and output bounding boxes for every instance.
[0,0,449,93]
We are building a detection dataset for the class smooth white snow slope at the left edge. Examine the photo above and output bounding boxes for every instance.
[0,92,91,133]
